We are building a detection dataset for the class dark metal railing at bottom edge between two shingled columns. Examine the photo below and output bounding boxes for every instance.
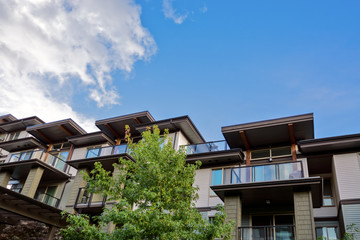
[239,225,295,240]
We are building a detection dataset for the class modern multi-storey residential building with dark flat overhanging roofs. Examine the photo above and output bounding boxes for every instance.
[0,111,360,240]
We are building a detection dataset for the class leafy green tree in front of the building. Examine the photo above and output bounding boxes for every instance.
[62,126,233,240]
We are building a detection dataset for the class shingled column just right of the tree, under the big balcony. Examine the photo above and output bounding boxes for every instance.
[224,196,242,240]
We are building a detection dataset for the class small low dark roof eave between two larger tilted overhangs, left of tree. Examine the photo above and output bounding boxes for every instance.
[68,132,115,147]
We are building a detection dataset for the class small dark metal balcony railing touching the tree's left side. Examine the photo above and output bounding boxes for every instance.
[75,188,106,208]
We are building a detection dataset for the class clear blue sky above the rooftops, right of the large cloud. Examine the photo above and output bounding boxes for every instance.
[0,0,360,141]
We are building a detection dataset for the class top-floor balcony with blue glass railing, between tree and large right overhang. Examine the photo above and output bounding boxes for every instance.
[183,140,244,166]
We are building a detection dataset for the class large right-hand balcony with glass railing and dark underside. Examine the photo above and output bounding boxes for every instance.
[210,161,323,208]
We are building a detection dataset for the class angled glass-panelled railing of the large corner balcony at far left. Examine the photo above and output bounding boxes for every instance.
[9,150,72,174]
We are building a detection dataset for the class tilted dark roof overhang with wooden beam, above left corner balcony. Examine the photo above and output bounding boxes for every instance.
[26,118,86,144]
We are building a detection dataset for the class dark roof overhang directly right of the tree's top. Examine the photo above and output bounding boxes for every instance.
[135,116,205,144]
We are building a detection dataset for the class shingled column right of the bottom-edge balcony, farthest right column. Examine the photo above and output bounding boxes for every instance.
[294,191,316,240]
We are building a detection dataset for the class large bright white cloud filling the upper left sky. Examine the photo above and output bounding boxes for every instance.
[0,0,156,129]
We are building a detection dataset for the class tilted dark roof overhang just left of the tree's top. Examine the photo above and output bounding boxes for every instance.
[95,111,155,139]
